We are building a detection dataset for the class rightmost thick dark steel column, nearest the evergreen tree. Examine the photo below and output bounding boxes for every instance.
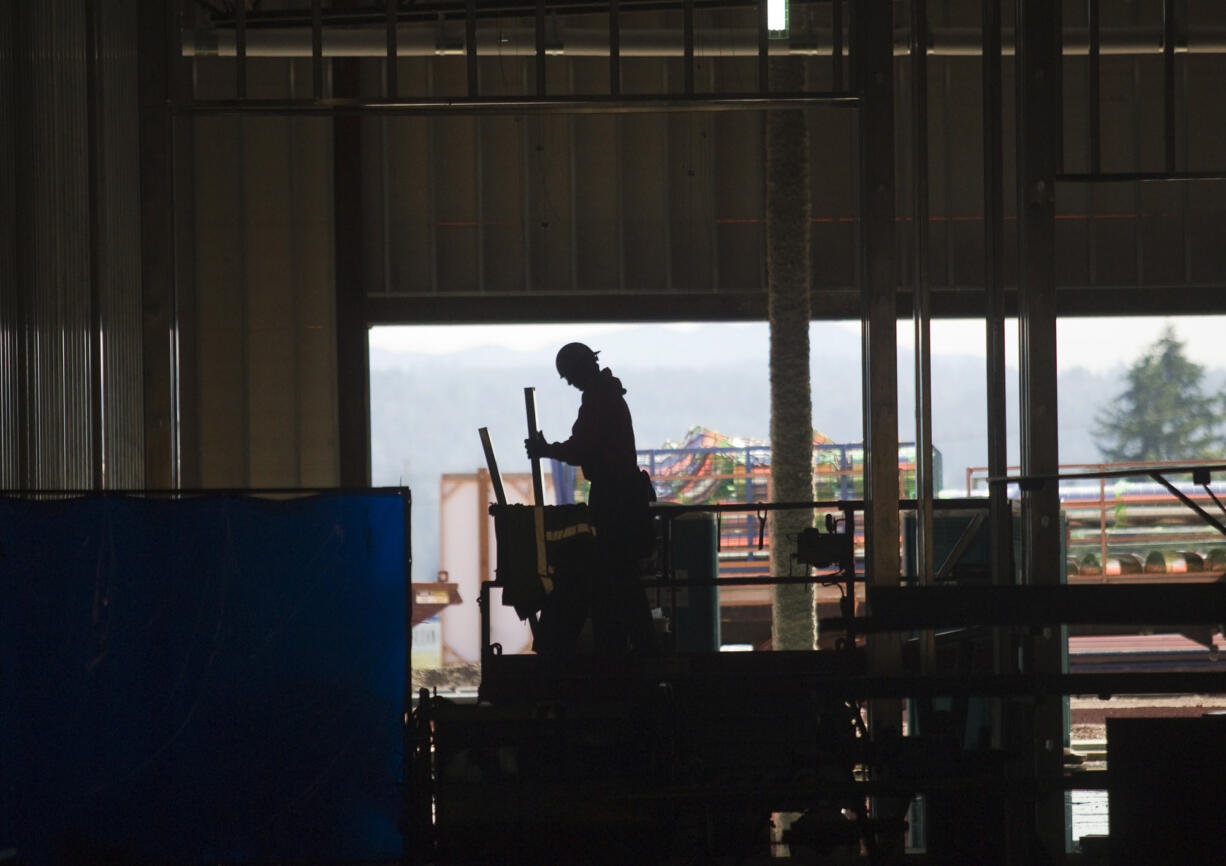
[1015,0,1064,862]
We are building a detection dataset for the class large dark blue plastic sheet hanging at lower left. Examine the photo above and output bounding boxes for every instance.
[0,489,409,864]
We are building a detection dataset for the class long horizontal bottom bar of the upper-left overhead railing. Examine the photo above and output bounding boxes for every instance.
[175,92,859,117]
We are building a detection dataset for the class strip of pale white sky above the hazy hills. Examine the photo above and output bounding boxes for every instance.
[370,316,1226,372]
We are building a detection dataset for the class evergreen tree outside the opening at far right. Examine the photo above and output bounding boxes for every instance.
[1094,325,1226,462]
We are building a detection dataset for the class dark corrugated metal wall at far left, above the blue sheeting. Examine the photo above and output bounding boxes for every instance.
[0,0,143,489]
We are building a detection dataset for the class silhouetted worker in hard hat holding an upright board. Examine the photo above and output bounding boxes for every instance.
[525,342,657,654]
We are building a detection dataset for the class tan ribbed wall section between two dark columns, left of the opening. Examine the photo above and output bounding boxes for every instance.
[190,60,345,487]
